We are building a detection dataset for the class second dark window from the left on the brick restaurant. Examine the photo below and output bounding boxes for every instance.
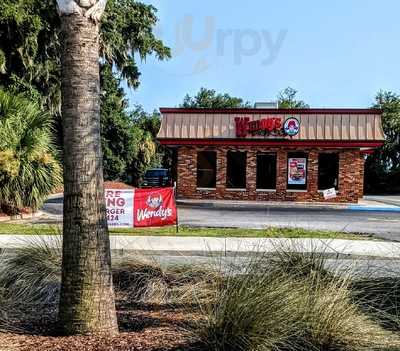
[226,151,246,189]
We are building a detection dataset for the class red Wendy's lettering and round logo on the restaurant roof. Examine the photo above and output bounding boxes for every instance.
[235,117,300,138]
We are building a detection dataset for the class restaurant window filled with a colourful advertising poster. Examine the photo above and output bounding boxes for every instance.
[287,152,307,190]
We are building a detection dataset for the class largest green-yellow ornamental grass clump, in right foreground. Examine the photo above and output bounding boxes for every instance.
[189,252,400,351]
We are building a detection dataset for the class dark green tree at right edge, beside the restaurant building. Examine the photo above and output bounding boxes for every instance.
[365,91,400,193]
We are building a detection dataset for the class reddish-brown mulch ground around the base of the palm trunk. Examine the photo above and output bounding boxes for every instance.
[0,305,192,351]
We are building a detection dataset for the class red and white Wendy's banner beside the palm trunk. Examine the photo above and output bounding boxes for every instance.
[105,188,177,228]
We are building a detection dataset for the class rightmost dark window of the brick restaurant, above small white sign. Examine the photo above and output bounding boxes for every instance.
[318,153,339,190]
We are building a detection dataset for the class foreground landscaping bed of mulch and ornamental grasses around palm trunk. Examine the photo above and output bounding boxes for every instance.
[0,239,400,351]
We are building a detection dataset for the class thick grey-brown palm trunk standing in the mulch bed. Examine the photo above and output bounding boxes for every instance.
[59,13,118,335]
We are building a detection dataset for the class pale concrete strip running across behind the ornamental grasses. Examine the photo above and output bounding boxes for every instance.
[0,235,400,259]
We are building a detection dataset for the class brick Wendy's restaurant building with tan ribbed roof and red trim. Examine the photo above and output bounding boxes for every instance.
[158,108,384,203]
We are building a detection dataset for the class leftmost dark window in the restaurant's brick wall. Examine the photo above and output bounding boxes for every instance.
[197,151,217,188]
